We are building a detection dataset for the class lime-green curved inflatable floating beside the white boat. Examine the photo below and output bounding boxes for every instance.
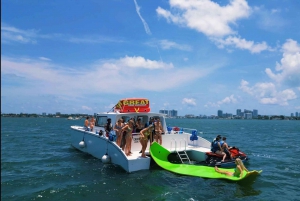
[150,142,261,181]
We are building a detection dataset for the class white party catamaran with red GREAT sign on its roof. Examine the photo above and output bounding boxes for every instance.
[71,98,216,172]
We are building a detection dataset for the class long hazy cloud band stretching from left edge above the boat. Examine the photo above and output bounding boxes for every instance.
[1,56,211,97]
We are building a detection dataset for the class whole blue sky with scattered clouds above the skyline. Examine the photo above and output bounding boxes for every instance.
[1,0,300,115]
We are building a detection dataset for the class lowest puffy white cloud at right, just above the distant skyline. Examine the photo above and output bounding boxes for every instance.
[239,80,297,105]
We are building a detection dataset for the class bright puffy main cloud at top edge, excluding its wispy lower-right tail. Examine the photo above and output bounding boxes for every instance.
[156,0,251,37]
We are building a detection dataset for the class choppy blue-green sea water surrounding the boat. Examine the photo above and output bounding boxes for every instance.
[1,118,300,201]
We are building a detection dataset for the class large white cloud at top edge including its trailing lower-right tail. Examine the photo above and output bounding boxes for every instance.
[156,0,274,53]
